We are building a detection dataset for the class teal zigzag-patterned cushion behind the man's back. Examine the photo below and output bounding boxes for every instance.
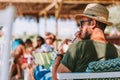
[86,58,120,72]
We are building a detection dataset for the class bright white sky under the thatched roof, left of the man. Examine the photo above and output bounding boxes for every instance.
[12,16,79,38]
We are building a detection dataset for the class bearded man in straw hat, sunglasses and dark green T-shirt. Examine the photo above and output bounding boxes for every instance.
[52,4,118,80]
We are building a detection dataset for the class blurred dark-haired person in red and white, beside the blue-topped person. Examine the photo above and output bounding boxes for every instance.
[22,38,34,80]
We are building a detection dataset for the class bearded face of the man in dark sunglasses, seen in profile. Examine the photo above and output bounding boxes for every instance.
[80,17,92,40]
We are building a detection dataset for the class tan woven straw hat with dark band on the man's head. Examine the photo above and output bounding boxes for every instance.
[75,3,112,26]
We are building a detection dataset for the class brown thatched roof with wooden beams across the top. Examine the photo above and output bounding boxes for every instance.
[0,0,120,18]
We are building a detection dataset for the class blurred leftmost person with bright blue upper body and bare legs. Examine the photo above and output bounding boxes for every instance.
[10,39,25,80]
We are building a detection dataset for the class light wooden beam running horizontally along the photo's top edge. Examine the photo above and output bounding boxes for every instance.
[0,0,120,4]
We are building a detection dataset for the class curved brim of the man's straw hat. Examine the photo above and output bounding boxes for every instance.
[75,14,112,26]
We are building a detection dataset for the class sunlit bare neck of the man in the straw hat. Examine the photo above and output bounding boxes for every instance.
[91,28,107,43]
